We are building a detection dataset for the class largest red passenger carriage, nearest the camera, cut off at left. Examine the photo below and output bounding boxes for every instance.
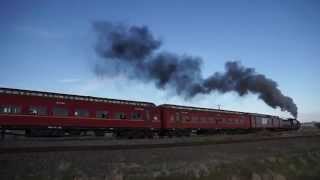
[0,88,161,135]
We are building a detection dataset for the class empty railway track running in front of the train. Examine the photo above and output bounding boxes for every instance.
[0,134,320,154]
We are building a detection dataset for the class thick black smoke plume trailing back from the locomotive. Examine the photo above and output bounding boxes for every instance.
[94,22,297,117]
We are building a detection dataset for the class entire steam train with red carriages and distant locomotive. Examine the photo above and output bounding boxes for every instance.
[0,88,300,138]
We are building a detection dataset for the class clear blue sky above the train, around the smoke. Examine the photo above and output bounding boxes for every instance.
[0,0,320,121]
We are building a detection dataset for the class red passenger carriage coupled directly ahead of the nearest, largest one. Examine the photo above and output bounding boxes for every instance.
[159,104,251,133]
